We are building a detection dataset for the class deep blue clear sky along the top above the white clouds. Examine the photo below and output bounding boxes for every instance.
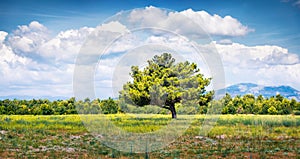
[0,0,300,52]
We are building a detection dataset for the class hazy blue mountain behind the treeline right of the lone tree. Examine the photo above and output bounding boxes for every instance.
[226,83,300,101]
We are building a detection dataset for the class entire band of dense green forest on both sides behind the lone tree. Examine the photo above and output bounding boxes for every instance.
[0,94,300,115]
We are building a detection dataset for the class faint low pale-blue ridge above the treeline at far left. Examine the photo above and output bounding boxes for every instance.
[0,95,69,101]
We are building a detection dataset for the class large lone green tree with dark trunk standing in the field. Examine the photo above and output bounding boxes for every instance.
[120,53,213,118]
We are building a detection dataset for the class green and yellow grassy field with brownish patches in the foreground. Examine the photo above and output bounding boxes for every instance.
[0,114,300,158]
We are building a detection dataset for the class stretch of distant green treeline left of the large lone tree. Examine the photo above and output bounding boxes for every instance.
[0,97,120,115]
